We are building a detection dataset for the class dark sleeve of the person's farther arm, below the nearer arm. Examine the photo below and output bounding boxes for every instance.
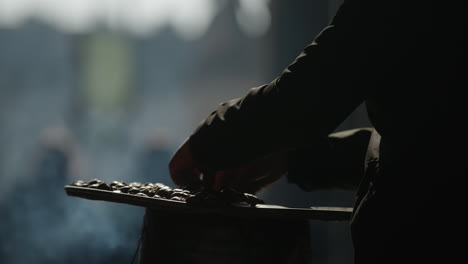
[287,128,373,191]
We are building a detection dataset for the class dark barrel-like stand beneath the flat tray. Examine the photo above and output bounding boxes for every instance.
[139,208,310,264]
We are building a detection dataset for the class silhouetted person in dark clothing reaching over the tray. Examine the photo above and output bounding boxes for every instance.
[170,0,468,263]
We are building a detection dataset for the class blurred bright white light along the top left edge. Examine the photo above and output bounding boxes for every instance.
[0,0,271,39]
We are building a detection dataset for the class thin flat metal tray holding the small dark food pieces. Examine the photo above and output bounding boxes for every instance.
[65,185,353,221]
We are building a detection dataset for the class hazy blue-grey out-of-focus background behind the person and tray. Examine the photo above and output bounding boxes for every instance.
[0,0,369,264]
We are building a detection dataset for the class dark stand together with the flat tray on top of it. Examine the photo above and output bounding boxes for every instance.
[65,183,352,264]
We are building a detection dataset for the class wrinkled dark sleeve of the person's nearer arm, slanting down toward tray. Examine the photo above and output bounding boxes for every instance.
[189,0,386,170]
